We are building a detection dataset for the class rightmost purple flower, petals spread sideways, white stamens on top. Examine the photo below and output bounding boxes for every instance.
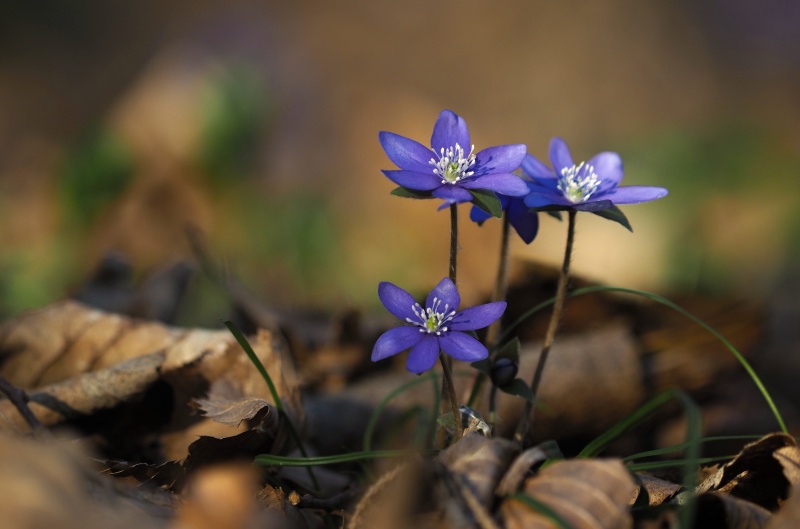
[522,138,668,212]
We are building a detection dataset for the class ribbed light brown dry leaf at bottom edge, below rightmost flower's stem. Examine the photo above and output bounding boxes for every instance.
[500,459,636,529]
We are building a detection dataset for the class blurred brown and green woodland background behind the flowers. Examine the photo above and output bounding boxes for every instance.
[0,0,800,326]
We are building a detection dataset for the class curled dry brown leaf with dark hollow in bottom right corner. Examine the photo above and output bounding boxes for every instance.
[696,433,798,511]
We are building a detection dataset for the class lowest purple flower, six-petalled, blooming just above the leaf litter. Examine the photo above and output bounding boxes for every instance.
[372,278,506,374]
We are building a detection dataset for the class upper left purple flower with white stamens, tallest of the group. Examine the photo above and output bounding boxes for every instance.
[378,110,528,206]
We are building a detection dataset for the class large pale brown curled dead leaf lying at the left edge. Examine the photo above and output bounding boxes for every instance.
[0,301,302,454]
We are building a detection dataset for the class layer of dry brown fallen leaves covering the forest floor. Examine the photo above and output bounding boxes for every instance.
[0,262,800,528]
